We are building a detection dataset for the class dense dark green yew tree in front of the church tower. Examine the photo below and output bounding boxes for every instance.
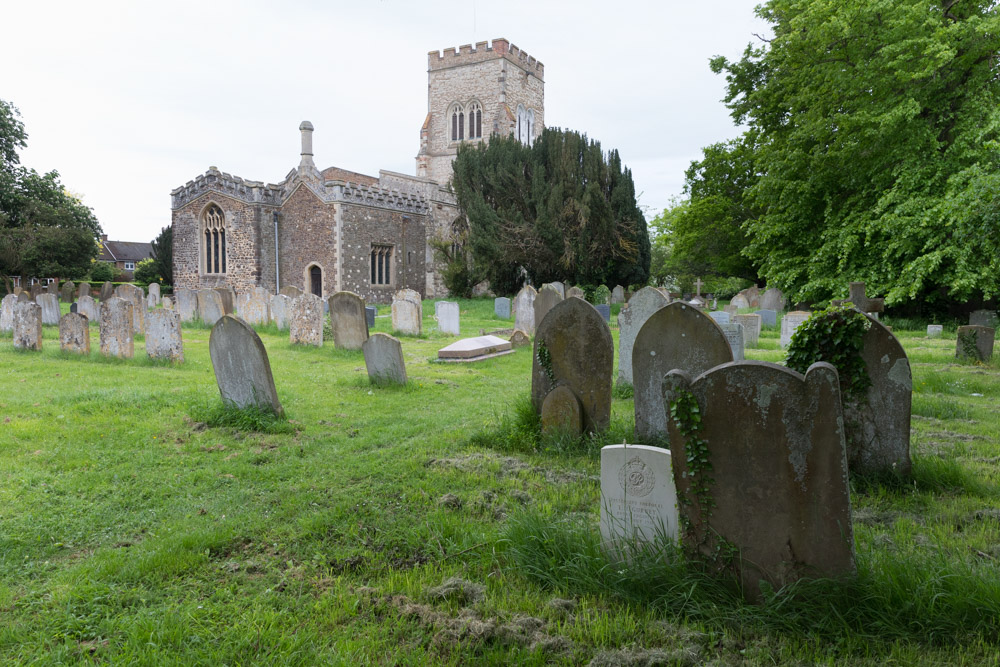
[452,129,650,293]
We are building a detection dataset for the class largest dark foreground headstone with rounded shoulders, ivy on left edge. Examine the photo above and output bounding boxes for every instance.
[663,361,855,598]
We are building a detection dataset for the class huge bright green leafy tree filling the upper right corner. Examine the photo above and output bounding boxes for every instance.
[712,0,1000,302]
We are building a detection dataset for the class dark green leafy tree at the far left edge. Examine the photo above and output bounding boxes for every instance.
[0,100,101,290]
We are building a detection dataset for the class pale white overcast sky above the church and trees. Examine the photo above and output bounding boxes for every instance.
[0,0,767,241]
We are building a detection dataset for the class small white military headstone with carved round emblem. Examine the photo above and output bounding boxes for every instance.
[601,444,680,561]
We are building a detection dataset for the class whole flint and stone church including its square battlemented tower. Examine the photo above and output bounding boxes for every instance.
[170,39,544,303]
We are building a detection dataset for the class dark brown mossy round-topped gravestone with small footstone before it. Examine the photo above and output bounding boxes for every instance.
[531,298,615,432]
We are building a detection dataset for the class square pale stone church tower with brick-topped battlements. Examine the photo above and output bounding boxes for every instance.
[417,39,545,185]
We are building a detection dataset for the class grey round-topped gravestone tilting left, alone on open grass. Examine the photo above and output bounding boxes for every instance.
[208,315,285,415]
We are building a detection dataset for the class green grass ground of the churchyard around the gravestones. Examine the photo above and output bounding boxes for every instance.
[0,300,1000,665]
